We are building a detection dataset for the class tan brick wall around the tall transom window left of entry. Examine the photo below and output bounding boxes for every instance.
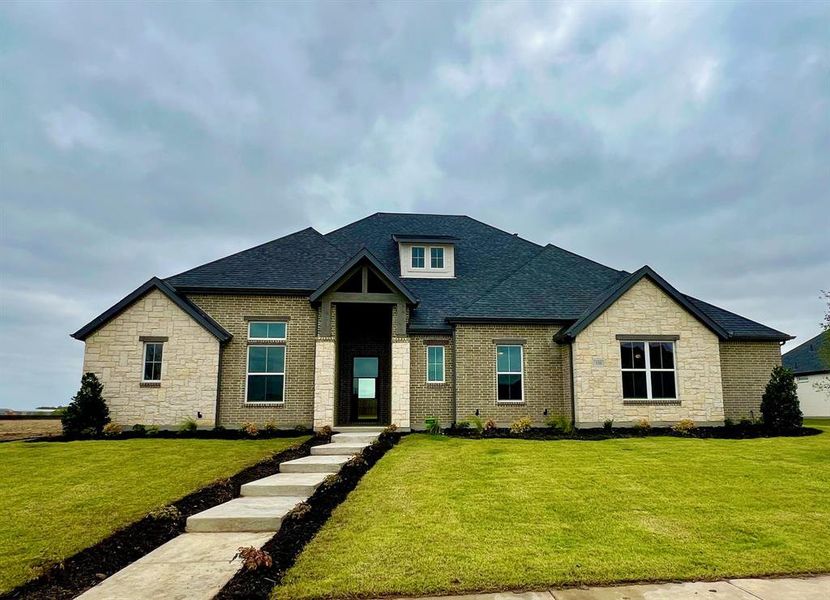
[188,294,317,429]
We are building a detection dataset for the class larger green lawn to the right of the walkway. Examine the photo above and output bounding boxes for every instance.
[274,422,830,599]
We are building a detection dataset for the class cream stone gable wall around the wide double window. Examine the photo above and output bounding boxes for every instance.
[573,279,724,427]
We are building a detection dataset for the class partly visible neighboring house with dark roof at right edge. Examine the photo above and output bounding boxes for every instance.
[781,331,830,417]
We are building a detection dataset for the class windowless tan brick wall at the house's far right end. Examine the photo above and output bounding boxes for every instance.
[720,342,781,420]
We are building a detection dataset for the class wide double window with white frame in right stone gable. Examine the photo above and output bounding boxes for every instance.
[620,341,677,400]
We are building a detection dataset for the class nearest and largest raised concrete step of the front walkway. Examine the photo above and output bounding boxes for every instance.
[187,496,306,533]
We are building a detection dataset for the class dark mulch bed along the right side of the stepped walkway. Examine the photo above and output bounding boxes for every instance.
[216,432,400,600]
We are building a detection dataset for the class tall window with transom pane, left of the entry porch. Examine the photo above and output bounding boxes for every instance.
[245,321,286,403]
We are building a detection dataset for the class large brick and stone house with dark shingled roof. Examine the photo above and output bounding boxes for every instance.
[73,213,790,429]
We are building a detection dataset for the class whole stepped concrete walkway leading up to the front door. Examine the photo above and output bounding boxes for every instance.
[78,428,381,600]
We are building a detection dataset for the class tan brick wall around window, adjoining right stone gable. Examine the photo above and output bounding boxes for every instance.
[455,324,570,426]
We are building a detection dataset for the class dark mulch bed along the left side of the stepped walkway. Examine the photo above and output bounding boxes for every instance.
[0,437,330,600]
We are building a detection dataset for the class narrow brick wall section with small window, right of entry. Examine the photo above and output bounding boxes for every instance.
[409,335,462,429]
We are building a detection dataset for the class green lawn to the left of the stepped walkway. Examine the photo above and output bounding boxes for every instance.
[0,437,306,593]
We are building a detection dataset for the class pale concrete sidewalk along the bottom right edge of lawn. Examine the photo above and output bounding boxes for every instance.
[400,575,830,600]
